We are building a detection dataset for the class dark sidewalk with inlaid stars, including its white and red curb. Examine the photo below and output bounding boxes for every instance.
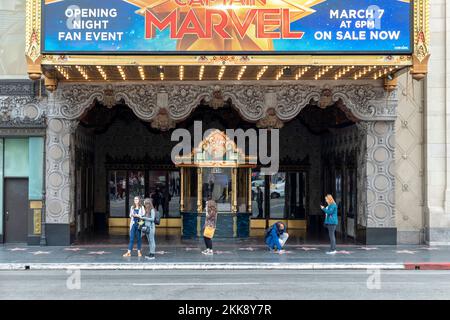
[0,241,450,270]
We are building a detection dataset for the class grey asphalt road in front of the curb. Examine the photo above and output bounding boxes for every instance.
[0,270,450,300]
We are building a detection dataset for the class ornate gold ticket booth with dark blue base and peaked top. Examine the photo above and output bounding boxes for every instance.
[176,130,256,238]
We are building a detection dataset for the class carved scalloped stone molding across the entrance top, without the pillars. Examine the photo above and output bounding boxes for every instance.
[52,83,397,126]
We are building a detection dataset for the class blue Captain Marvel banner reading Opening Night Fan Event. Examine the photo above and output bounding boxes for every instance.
[42,0,413,55]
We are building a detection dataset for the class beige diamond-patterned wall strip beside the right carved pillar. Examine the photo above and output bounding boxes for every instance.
[395,73,425,244]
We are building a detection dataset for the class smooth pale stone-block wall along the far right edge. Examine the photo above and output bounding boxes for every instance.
[425,0,450,245]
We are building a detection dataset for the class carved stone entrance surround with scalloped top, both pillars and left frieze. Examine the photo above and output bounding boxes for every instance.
[0,82,398,242]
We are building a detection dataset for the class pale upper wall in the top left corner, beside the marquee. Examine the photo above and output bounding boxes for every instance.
[0,0,28,79]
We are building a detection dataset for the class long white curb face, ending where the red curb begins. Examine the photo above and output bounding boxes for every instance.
[0,263,405,271]
